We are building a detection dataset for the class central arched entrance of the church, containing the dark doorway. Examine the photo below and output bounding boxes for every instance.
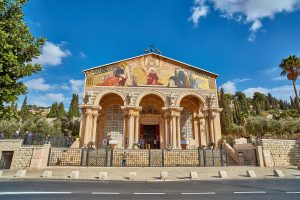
[139,94,164,149]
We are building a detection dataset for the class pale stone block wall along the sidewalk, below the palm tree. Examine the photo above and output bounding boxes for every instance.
[261,139,300,167]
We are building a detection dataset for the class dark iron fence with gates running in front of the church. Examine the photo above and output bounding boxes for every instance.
[48,148,257,167]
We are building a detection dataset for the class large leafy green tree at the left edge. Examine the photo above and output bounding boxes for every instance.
[0,0,45,118]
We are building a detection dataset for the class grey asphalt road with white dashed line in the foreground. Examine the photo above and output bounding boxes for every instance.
[0,179,300,200]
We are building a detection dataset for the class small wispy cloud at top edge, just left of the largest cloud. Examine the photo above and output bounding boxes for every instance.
[188,0,209,27]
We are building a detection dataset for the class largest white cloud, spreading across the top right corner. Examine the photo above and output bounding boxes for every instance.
[189,0,300,41]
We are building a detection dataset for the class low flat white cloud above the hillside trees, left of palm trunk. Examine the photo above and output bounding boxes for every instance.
[243,85,300,101]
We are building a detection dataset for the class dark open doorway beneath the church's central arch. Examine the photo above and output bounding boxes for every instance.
[141,125,160,149]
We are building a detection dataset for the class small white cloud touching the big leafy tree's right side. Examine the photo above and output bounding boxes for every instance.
[33,42,72,66]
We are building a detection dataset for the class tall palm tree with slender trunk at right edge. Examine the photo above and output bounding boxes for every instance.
[279,55,300,111]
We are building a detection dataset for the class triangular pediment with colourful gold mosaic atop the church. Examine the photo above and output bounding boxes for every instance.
[83,53,218,89]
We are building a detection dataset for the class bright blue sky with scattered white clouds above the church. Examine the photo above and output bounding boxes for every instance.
[19,0,300,107]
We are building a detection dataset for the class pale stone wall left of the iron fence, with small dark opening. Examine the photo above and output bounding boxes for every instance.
[0,140,50,169]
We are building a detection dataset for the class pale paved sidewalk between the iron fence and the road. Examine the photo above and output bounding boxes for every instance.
[0,166,300,181]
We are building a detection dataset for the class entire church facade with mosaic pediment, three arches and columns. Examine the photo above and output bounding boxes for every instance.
[80,52,222,149]
